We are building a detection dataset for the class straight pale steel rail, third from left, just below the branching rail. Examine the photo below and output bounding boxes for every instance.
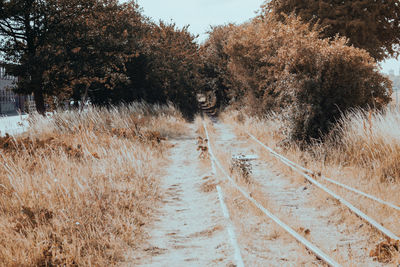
[249,134,400,240]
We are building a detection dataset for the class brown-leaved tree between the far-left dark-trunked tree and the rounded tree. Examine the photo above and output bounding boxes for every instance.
[44,0,144,109]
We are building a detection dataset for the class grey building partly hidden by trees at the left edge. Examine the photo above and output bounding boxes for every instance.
[0,64,34,114]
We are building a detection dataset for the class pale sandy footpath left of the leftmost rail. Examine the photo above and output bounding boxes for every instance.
[134,126,234,266]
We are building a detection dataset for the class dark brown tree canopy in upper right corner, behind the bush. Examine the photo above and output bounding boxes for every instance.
[264,0,400,61]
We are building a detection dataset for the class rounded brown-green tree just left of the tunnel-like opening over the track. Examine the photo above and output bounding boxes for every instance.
[136,22,202,119]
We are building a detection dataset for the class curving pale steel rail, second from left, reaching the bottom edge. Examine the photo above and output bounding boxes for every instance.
[203,121,341,266]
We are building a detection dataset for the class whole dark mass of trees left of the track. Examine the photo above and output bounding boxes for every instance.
[0,0,200,118]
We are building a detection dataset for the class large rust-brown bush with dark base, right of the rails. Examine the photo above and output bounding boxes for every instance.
[280,36,391,142]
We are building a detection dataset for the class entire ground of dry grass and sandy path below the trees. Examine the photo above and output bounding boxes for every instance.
[0,103,400,266]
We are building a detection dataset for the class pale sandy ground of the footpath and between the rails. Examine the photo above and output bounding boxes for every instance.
[133,123,395,266]
